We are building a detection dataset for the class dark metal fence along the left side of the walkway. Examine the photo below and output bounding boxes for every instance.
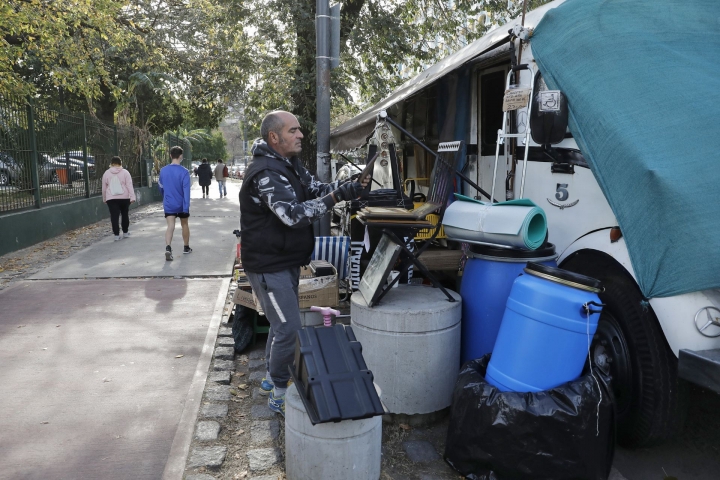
[0,96,160,213]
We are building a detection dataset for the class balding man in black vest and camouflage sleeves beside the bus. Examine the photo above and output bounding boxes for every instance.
[240,111,362,415]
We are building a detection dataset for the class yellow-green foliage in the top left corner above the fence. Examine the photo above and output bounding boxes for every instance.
[0,0,132,98]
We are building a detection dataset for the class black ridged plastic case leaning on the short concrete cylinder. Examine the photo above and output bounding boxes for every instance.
[290,325,385,425]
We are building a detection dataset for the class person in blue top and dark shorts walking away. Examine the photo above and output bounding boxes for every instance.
[158,146,192,260]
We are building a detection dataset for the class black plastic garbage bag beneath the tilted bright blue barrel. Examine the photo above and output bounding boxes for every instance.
[445,354,615,480]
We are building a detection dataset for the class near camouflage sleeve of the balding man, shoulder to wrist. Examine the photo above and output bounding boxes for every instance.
[252,170,334,228]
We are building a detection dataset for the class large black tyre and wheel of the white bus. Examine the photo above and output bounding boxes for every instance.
[563,257,682,448]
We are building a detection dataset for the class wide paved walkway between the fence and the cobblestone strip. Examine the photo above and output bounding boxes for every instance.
[0,182,239,479]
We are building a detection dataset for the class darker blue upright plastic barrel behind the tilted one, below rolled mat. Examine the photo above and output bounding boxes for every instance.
[460,243,557,363]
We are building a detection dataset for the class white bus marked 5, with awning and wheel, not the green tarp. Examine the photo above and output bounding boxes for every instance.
[331,0,720,447]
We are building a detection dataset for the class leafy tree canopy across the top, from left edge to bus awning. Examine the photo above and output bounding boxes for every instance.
[0,0,547,165]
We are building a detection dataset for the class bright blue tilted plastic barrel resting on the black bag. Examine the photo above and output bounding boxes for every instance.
[485,263,602,392]
